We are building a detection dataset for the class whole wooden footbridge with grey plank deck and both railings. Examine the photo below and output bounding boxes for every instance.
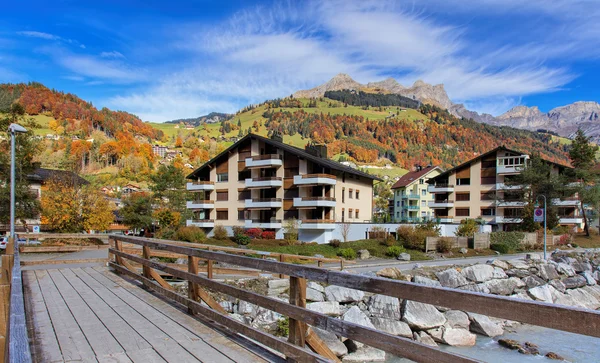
[0,236,600,363]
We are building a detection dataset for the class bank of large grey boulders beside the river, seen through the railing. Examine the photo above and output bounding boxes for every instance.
[204,250,600,362]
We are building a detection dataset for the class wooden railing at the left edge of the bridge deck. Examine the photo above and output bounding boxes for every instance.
[0,242,31,363]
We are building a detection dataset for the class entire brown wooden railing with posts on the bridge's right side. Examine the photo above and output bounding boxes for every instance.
[109,236,600,362]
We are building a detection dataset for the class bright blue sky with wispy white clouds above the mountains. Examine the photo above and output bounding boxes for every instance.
[0,0,600,121]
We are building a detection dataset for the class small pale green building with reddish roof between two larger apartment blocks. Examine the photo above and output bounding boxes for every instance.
[392,166,442,223]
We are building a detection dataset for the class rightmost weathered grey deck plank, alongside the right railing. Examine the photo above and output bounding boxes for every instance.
[95,267,279,363]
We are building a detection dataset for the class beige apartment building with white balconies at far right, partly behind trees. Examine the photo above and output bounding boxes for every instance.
[428,146,583,230]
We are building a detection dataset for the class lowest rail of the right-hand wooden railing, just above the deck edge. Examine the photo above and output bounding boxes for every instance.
[110,263,324,362]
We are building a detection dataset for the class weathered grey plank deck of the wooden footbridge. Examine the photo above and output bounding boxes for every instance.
[23,267,279,363]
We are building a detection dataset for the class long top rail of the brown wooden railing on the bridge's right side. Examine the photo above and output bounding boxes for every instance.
[112,237,600,337]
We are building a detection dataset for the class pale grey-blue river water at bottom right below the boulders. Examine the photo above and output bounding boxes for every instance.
[386,325,600,363]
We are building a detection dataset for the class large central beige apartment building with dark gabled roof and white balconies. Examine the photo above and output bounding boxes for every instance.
[187,134,380,241]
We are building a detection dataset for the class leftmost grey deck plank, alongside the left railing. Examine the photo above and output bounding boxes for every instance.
[23,271,64,362]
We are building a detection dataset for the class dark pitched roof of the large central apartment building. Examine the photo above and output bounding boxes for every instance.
[187,133,382,181]
